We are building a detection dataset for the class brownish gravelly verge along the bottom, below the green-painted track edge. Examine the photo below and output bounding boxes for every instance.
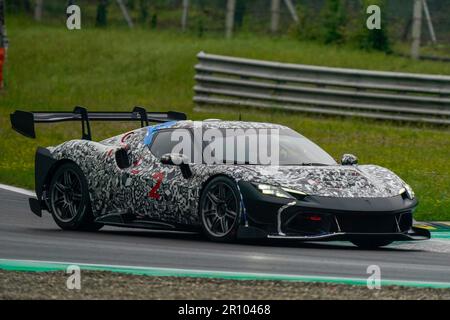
[0,270,450,300]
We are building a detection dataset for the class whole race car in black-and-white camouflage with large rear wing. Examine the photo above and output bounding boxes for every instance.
[11,107,430,248]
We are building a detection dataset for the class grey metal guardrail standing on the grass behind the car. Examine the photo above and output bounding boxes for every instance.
[194,52,450,125]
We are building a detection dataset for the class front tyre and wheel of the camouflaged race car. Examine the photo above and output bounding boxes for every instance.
[199,176,241,242]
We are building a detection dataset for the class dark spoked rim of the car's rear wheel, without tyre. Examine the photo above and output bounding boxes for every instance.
[51,169,83,222]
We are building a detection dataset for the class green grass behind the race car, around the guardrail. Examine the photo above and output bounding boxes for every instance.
[0,17,450,220]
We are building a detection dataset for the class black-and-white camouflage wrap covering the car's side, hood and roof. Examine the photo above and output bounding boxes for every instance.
[48,121,412,224]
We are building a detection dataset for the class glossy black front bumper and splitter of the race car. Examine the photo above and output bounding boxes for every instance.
[238,181,430,241]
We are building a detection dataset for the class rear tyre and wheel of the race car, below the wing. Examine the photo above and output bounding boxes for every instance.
[49,162,103,231]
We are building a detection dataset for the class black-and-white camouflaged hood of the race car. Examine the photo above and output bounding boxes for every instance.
[240,165,408,198]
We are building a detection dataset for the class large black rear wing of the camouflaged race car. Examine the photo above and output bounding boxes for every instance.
[10,106,187,140]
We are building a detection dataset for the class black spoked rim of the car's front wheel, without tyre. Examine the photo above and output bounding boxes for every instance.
[202,182,239,237]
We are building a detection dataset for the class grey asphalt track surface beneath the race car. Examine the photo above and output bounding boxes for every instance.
[0,190,450,282]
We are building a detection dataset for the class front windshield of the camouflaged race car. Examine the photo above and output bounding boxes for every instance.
[203,129,336,165]
